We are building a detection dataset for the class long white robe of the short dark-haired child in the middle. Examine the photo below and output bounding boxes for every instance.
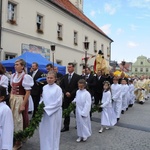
[73,89,92,138]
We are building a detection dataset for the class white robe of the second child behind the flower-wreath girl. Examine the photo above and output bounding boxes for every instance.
[121,84,129,111]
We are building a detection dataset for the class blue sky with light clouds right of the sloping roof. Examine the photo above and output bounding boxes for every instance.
[83,0,150,62]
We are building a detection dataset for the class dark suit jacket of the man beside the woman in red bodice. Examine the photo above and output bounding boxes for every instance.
[30,70,43,95]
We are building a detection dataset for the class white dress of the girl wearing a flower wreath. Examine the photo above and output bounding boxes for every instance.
[101,91,117,127]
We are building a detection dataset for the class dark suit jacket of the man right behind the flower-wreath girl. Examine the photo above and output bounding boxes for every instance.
[94,76,105,93]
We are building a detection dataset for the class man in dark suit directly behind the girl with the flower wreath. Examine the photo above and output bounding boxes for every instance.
[94,70,105,105]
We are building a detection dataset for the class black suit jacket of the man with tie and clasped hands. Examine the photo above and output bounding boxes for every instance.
[60,73,80,101]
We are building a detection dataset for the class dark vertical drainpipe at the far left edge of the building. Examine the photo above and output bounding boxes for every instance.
[0,0,2,61]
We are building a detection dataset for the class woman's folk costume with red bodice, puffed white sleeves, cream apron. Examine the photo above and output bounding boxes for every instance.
[10,71,33,132]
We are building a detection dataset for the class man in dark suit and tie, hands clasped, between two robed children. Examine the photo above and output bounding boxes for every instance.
[60,63,80,132]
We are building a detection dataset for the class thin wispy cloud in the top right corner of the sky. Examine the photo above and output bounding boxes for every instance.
[128,0,150,9]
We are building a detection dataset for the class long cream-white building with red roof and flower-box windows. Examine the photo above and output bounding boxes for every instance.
[0,0,113,73]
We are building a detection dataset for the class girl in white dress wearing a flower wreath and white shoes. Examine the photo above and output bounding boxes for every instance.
[99,81,117,133]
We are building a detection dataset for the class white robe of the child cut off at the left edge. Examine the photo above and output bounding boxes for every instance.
[0,102,14,150]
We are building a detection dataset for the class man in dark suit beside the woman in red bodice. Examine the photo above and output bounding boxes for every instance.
[30,62,43,117]
